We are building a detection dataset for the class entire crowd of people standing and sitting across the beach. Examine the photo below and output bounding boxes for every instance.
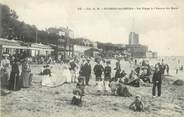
[0,54,181,111]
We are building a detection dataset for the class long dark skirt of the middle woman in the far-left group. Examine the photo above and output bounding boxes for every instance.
[9,72,21,91]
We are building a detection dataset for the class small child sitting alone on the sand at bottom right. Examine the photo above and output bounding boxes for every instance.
[129,95,144,112]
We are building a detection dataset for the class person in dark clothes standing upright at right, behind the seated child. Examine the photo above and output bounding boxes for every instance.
[152,65,162,97]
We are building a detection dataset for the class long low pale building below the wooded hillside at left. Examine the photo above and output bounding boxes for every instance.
[0,38,54,60]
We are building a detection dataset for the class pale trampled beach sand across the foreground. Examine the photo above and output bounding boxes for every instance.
[0,59,184,117]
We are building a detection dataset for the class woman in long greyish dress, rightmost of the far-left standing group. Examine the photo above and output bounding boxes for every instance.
[21,58,32,88]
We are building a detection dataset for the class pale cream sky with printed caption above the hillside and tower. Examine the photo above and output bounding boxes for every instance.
[0,0,184,56]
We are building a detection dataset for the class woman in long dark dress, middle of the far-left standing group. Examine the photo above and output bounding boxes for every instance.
[9,58,21,91]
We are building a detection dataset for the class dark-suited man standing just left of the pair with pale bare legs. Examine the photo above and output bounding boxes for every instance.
[83,59,91,85]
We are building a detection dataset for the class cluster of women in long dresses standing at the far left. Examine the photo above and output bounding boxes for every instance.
[0,54,33,91]
